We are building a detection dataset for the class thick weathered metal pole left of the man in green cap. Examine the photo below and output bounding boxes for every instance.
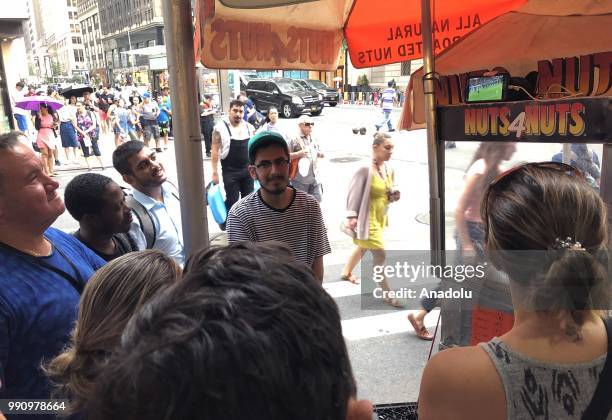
[163,0,208,256]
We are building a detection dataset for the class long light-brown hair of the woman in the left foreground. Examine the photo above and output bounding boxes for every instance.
[45,250,181,418]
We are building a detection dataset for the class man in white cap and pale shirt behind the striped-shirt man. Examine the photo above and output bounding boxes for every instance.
[289,115,324,203]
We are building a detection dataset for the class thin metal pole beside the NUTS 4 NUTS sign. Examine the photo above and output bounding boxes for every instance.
[421,0,444,265]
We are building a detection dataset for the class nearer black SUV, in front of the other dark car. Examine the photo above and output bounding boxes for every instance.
[246,78,325,118]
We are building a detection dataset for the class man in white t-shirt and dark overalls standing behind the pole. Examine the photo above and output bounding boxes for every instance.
[211,100,255,230]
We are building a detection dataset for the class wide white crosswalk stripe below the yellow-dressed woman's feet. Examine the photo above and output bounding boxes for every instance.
[342,309,440,341]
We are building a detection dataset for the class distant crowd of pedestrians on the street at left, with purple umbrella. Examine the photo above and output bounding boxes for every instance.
[11,82,172,176]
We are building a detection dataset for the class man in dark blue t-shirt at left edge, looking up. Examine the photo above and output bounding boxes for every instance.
[0,132,104,418]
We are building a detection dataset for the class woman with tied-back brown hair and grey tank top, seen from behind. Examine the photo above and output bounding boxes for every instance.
[419,162,612,420]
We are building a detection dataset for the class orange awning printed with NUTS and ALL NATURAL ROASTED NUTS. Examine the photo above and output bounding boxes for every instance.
[196,0,526,70]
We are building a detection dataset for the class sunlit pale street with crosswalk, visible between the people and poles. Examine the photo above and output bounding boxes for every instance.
[49,105,601,404]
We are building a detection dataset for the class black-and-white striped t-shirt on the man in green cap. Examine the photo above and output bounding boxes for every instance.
[227,187,331,267]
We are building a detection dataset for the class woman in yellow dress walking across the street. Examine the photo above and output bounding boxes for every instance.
[342,132,402,307]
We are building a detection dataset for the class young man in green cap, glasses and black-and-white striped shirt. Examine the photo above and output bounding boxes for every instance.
[227,131,331,282]
